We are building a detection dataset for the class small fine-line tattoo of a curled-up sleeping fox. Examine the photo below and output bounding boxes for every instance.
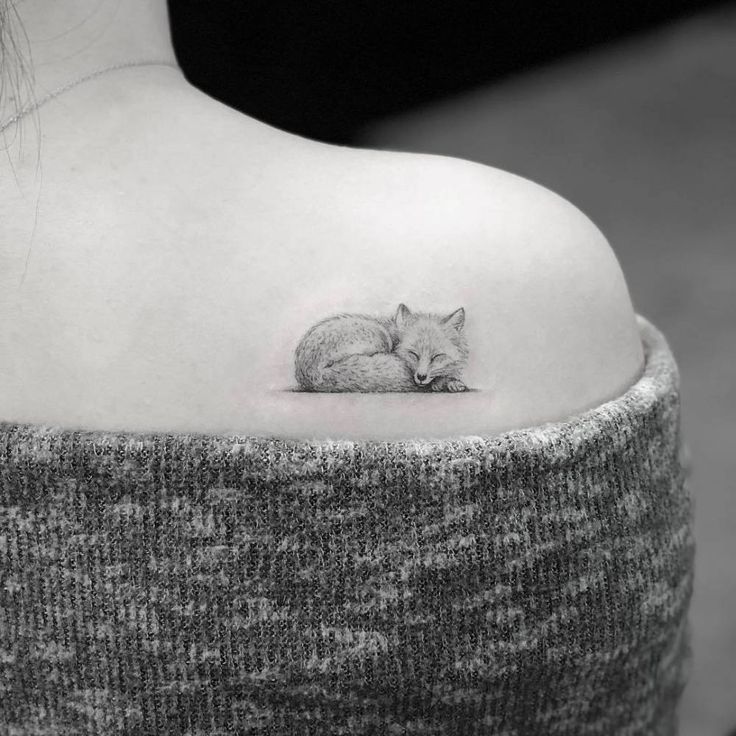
[294,304,468,392]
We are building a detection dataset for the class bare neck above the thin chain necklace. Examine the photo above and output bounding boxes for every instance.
[11,0,176,97]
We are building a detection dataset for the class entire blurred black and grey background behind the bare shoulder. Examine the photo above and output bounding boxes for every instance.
[170,0,736,736]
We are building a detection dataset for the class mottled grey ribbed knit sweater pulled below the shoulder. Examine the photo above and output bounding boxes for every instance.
[0,316,695,736]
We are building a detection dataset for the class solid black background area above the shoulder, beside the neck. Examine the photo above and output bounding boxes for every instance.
[170,0,728,144]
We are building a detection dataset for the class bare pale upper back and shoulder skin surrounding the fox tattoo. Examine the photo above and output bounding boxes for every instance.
[0,0,643,439]
